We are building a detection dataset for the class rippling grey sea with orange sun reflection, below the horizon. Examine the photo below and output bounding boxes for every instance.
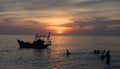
[0,35,120,69]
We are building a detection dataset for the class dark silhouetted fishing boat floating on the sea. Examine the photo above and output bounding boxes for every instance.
[17,32,51,49]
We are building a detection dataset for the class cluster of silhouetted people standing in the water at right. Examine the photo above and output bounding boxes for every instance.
[94,50,111,64]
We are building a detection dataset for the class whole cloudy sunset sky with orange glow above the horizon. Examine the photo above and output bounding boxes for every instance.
[0,0,120,35]
